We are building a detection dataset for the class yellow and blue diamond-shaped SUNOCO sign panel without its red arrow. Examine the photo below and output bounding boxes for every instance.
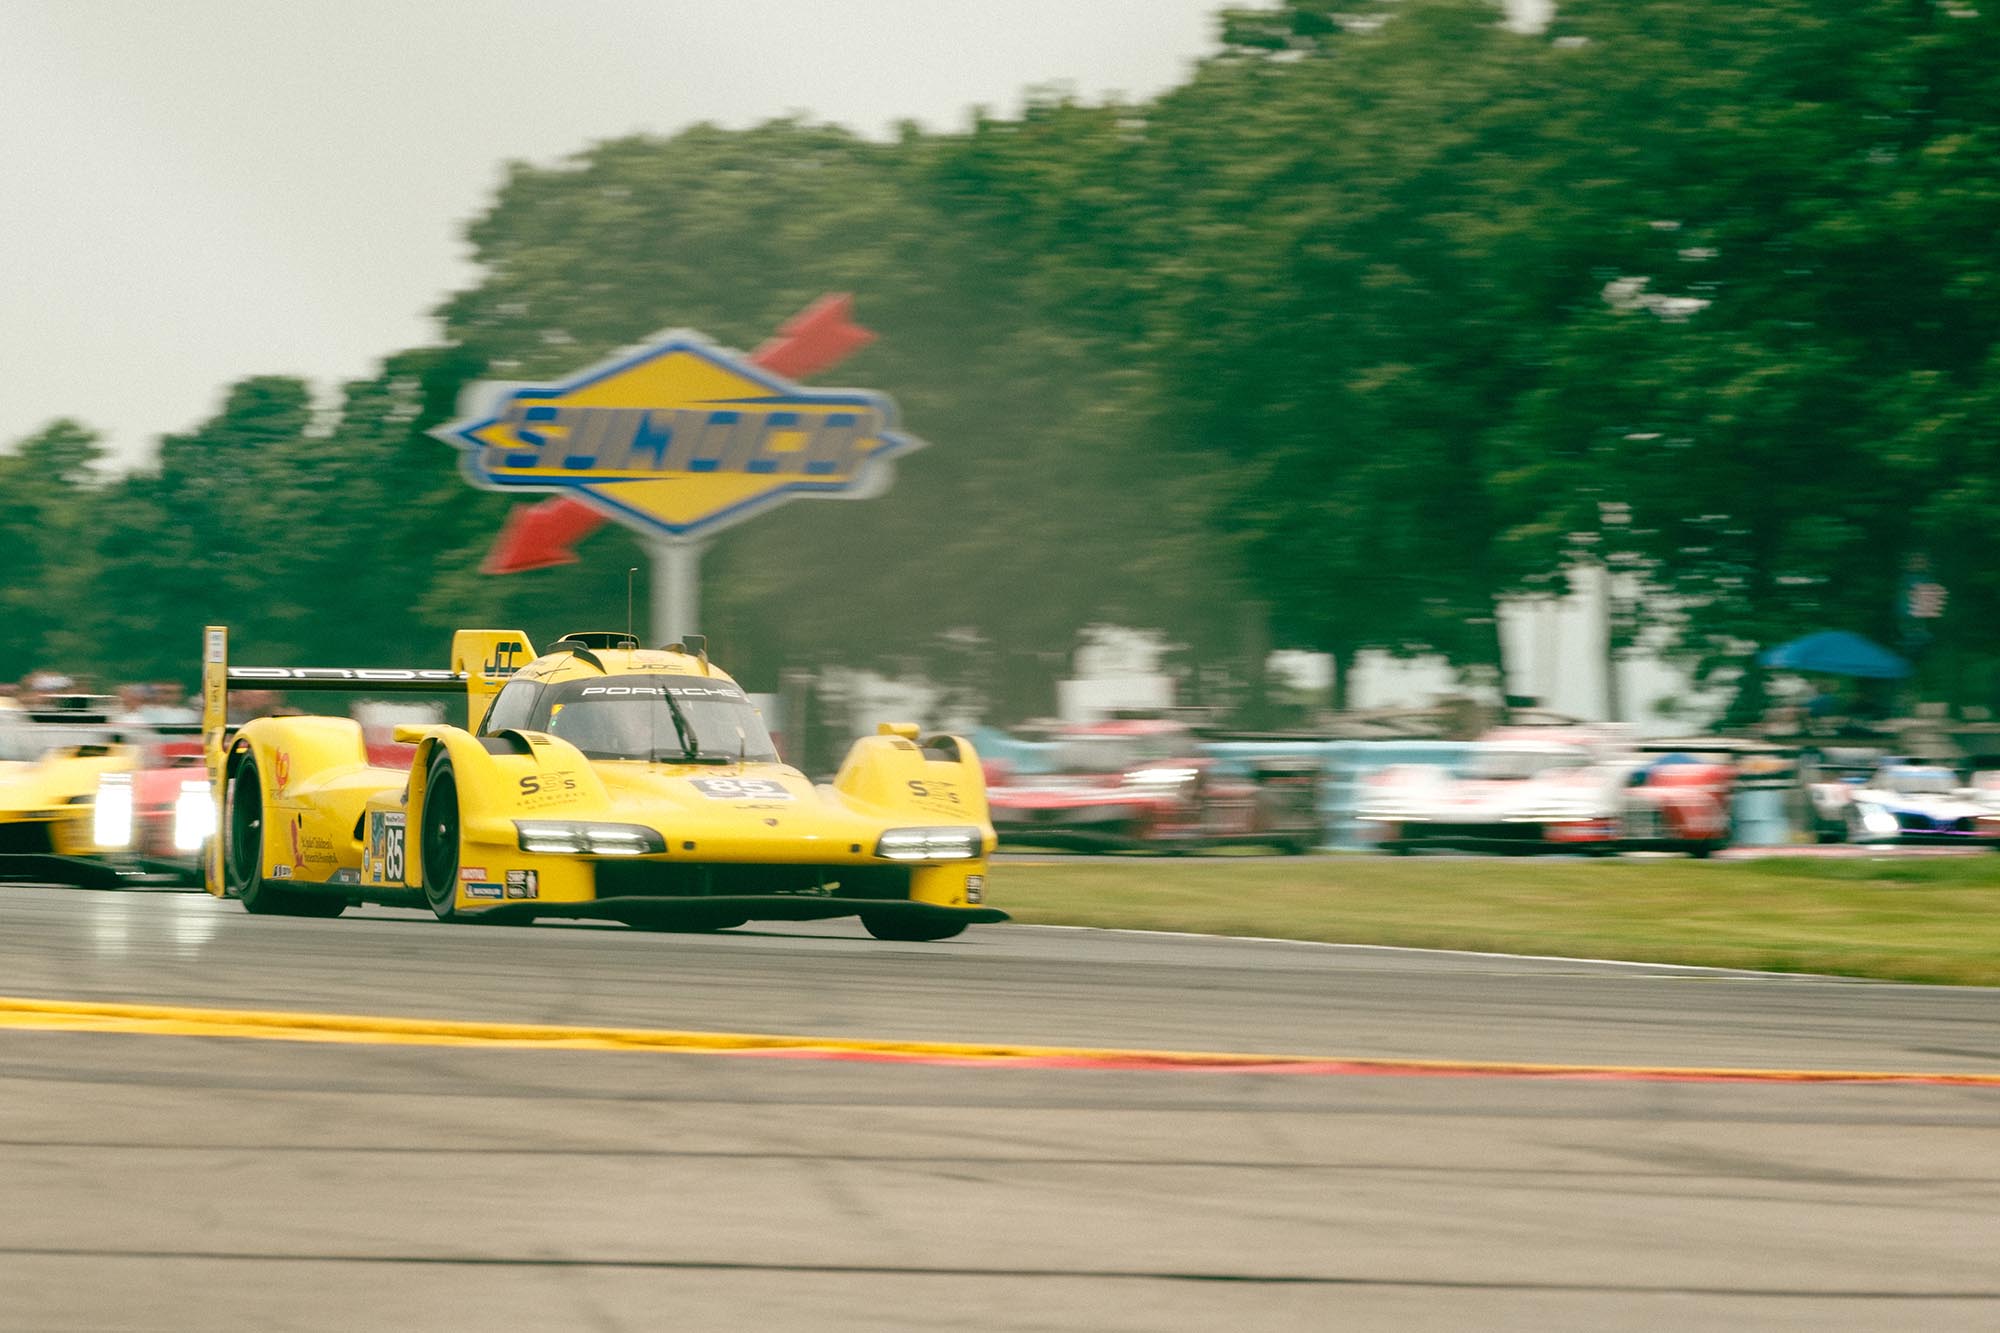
[432,330,922,536]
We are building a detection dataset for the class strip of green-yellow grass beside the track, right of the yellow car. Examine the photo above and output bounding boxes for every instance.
[994,857,2000,985]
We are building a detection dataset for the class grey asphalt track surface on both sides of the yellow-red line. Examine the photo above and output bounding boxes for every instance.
[0,876,2000,1329]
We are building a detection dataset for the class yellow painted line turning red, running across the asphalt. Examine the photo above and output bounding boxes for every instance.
[0,997,2000,1087]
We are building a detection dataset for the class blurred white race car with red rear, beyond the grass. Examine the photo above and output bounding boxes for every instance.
[1360,733,1734,857]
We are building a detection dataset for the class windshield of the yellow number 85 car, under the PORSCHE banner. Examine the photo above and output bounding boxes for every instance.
[532,677,778,765]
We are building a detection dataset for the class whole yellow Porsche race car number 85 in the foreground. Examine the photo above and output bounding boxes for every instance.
[202,626,1008,941]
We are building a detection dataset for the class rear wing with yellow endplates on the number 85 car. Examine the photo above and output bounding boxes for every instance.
[202,624,534,897]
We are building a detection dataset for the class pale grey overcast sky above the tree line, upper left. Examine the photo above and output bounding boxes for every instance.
[0,0,1242,460]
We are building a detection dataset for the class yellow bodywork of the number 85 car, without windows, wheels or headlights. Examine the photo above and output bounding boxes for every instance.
[208,630,1004,921]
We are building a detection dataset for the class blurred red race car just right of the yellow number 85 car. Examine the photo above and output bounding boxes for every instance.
[988,719,1320,853]
